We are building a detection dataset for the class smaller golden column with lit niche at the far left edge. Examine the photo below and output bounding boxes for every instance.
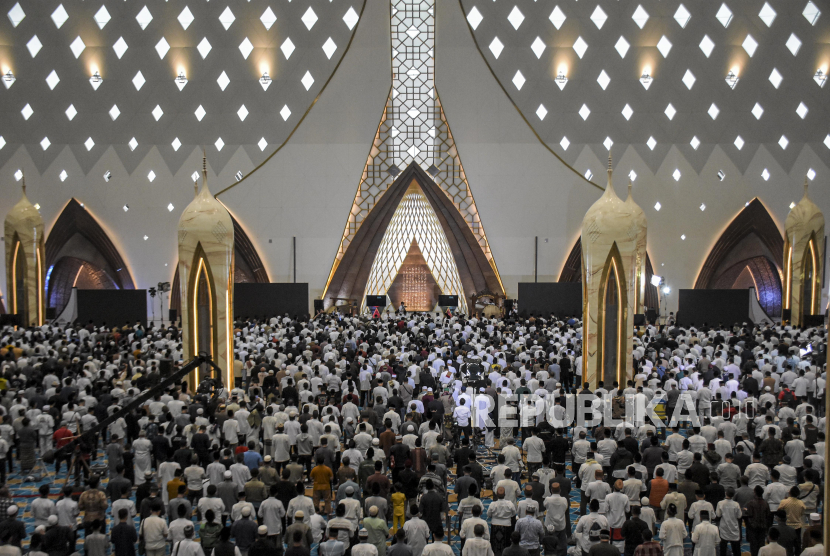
[4,176,46,326]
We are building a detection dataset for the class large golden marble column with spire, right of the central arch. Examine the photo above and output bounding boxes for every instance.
[582,155,647,388]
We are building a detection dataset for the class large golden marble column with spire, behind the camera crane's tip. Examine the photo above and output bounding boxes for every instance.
[179,158,234,388]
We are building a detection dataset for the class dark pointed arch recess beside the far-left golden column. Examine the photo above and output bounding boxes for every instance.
[45,198,135,314]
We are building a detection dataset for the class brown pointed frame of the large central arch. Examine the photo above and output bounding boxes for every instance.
[323,162,504,307]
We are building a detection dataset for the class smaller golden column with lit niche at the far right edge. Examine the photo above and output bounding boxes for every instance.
[784,178,824,326]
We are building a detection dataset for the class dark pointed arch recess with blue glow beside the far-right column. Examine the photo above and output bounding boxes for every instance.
[695,198,784,317]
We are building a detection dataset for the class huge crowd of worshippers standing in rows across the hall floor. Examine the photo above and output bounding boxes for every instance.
[0,313,826,556]
